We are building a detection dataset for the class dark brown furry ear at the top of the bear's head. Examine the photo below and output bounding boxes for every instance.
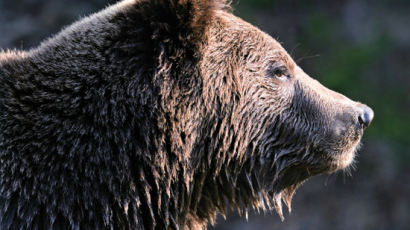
[148,0,227,42]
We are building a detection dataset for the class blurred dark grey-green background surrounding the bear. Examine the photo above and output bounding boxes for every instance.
[0,0,410,230]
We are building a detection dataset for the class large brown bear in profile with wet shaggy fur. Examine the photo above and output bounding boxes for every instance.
[0,0,374,229]
